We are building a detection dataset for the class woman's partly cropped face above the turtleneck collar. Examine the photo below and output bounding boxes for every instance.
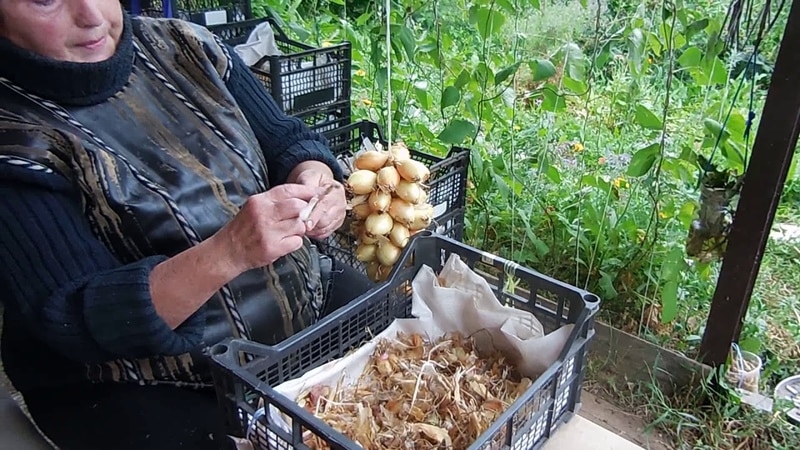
[0,0,123,63]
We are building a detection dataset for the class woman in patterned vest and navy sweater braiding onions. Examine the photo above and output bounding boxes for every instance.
[0,0,368,449]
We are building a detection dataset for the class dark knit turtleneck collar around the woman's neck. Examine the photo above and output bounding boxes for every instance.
[0,12,134,106]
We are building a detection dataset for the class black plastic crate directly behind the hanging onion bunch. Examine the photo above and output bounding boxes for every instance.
[319,121,470,273]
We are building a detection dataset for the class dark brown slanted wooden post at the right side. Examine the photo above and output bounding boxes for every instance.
[698,2,800,367]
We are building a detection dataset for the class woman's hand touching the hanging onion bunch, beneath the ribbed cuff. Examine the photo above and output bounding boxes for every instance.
[287,161,347,239]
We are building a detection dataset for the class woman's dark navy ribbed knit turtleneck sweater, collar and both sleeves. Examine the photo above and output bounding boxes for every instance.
[0,16,341,391]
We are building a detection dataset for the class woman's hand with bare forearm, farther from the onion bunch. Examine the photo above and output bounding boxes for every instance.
[214,184,318,273]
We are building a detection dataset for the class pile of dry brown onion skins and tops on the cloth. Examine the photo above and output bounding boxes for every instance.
[298,333,531,450]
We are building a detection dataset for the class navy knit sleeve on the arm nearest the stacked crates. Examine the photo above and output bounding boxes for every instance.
[222,47,342,185]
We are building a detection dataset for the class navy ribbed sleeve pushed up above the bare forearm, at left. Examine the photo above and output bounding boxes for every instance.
[0,165,204,362]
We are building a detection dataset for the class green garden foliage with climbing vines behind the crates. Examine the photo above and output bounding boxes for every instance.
[255,0,800,440]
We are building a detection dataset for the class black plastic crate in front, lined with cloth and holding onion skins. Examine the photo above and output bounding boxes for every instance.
[211,232,599,450]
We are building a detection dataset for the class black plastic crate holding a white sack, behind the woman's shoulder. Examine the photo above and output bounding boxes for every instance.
[208,17,352,117]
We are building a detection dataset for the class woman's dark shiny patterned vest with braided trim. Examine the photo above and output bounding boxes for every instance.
[0,18,324,385]
